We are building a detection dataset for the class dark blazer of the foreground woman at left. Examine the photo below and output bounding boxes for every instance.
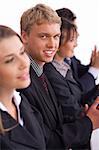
[0,94,46,150]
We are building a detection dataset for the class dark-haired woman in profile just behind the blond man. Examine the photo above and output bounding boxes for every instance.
[44,15,98,149]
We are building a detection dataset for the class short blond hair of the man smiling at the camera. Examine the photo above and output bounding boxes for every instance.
[20,4,61,34]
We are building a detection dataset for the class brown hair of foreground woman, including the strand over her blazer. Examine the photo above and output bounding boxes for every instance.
[0,25,22,133]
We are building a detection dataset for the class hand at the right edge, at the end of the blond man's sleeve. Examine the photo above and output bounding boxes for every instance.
[86,97,99,129]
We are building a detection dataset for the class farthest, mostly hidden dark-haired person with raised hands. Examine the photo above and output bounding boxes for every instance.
[56,8,99,99]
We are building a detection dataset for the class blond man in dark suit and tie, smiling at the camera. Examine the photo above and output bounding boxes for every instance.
[20,4,99,150]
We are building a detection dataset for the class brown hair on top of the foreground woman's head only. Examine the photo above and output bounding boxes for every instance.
[0,25,22,42]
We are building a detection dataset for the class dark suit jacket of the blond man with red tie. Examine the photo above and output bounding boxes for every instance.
[21,67,92,150]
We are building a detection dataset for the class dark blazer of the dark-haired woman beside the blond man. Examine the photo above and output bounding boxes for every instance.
[44,63,83,122]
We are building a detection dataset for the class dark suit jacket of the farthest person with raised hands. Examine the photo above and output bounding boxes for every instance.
[65,56,99,106]
